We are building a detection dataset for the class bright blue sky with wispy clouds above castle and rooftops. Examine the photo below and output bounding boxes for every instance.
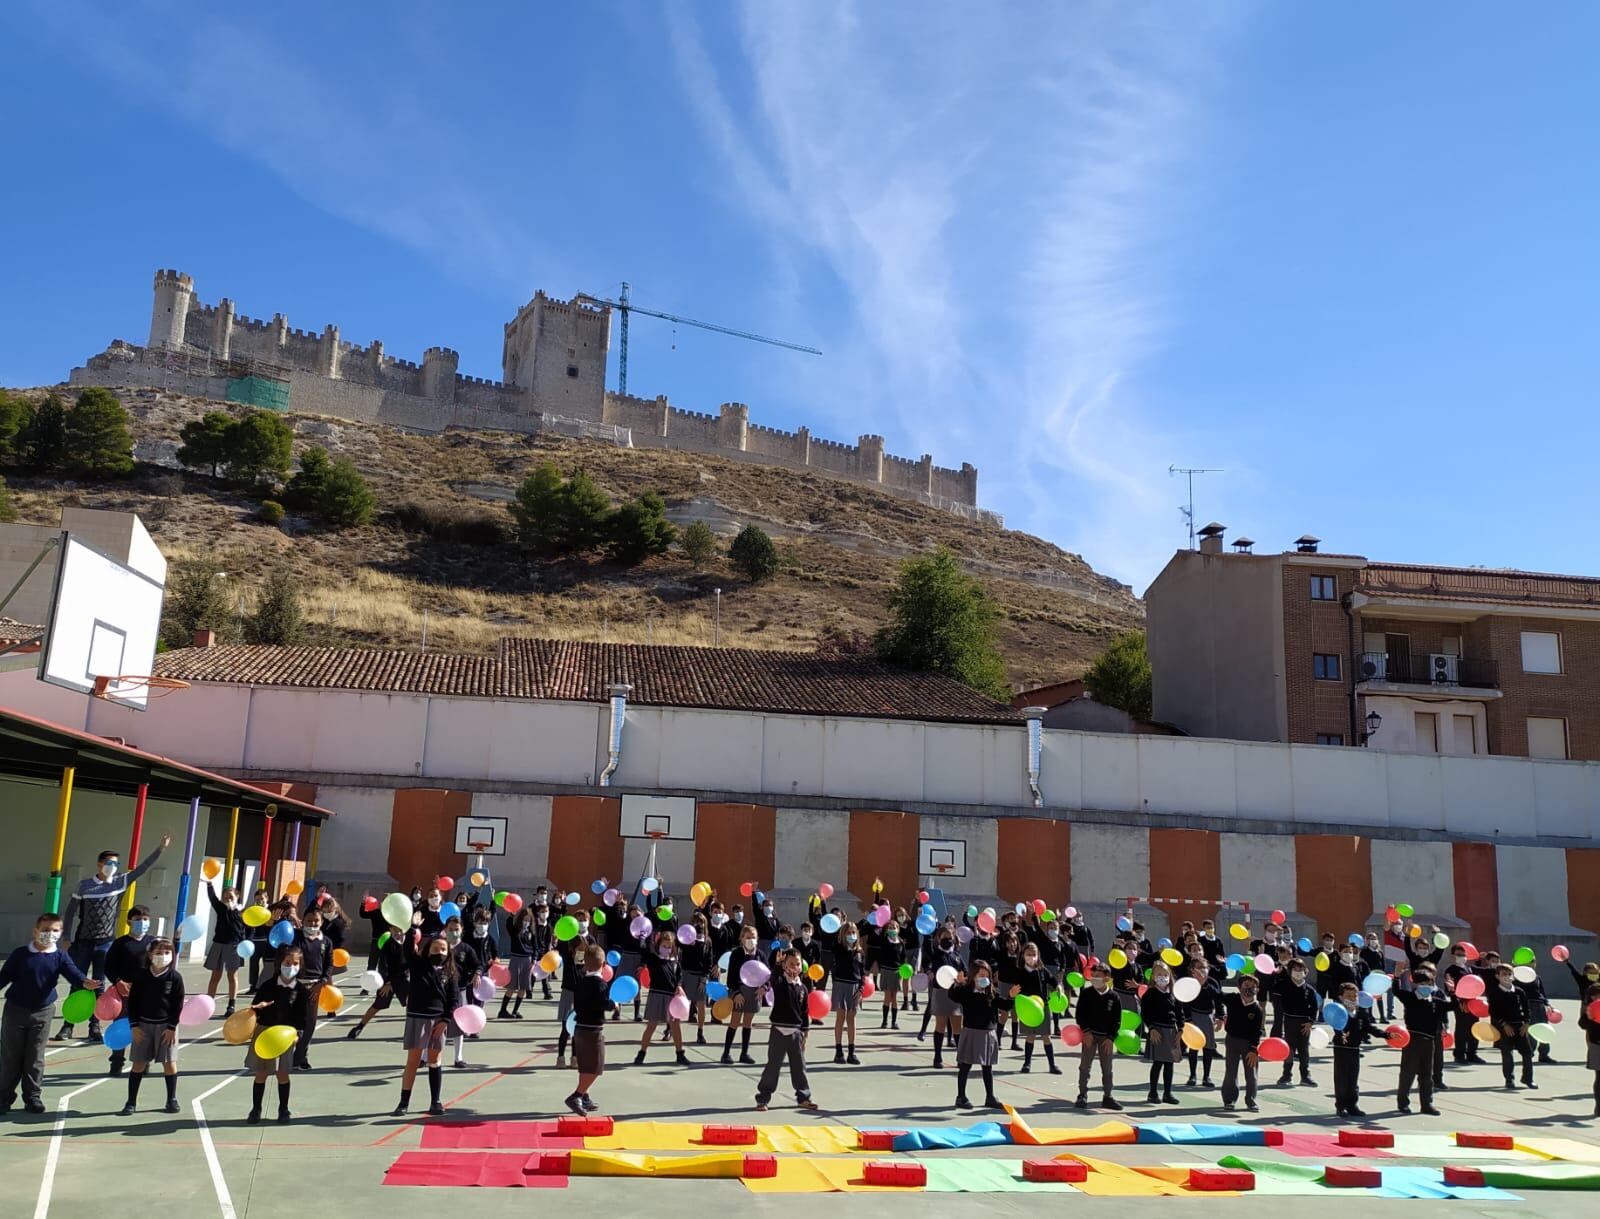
[0,0,1600,590]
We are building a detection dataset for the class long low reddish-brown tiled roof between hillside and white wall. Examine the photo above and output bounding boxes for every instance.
[155,640,1022,723]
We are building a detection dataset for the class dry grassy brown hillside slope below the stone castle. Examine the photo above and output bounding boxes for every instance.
[10,389,1142,685]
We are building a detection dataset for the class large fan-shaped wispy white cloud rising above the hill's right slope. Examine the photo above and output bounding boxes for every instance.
[672,3,1230,586]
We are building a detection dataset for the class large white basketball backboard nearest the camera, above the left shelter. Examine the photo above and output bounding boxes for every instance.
[38,534,165,710]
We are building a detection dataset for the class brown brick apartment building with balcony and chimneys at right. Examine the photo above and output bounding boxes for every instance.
[1144,523,1600,760]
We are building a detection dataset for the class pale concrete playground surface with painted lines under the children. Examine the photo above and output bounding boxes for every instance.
[0,971,1600,1219]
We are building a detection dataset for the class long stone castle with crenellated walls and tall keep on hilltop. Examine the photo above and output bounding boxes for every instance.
[70,270,998,523]
